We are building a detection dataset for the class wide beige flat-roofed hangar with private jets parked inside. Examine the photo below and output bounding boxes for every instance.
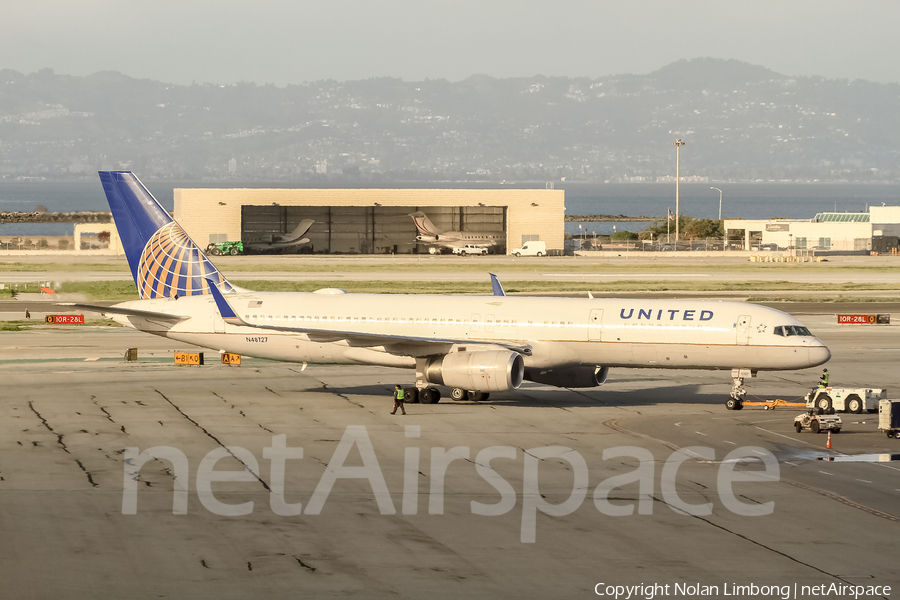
[174,188,565,254]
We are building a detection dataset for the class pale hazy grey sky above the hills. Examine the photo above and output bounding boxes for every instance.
[0,0,900,85]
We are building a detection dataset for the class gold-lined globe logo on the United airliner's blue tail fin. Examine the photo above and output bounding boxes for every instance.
[137,221,234,299]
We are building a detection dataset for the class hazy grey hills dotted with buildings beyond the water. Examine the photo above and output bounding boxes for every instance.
[0,58,900,183]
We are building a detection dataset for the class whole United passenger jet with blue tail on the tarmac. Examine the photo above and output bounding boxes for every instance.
[65,171,831,408]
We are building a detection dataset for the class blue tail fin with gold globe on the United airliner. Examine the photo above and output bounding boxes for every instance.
[100,171,235,300]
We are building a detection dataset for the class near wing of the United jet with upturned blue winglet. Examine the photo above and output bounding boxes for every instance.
[209,285,531,356]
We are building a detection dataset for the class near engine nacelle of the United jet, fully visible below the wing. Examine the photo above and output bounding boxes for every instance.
[425,350,525,392]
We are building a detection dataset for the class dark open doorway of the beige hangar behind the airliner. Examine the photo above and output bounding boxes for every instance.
[241,205,506,254]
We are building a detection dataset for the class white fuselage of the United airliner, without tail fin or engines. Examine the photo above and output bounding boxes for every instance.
[114,291,831,370]
